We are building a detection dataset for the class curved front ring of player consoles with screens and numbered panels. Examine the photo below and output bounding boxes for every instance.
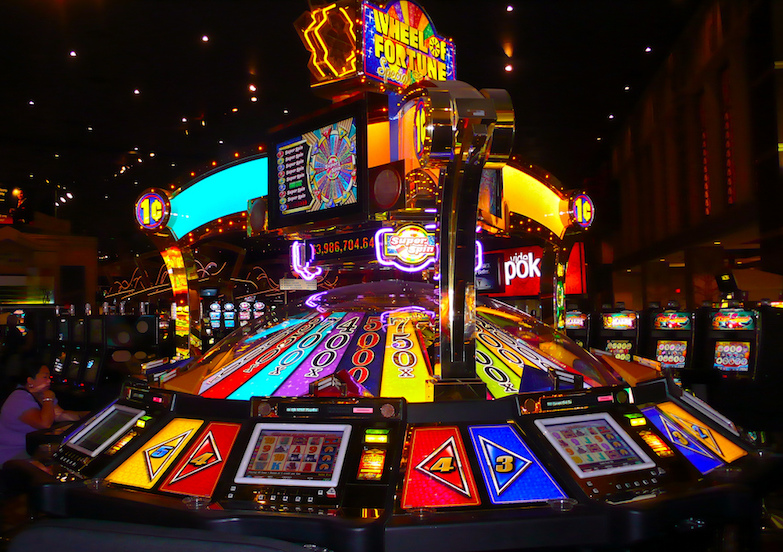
[23,379,773,552]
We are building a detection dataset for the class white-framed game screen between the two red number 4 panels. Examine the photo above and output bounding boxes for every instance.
[234,423,351,487]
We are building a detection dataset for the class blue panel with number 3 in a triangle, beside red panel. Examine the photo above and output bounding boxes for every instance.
[468,425,567,504]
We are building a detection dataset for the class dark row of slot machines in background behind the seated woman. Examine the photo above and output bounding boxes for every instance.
[39,315,172,403]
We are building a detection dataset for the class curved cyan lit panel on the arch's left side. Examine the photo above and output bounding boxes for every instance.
[168,156,269,240]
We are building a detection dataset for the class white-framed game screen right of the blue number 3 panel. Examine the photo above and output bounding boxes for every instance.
[535,412,656,479]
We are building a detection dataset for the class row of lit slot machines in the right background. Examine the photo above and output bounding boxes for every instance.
[566,305,783,431]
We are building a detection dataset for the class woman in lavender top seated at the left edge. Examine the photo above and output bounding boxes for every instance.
[0,359,86,466]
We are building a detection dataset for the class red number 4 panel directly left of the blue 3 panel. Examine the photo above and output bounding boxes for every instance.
[402,426,481,508]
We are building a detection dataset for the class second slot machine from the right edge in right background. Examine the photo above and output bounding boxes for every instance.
[639,303,696,387]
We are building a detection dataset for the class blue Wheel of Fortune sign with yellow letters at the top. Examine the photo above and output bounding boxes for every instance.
[362,0,456,87]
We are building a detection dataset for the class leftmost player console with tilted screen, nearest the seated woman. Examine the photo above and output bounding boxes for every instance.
[54,382,175,481]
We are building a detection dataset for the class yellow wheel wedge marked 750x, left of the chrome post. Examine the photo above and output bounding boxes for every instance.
[380,314,432,402]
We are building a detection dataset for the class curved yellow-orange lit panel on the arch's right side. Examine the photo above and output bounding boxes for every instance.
[503,165,571,239]
